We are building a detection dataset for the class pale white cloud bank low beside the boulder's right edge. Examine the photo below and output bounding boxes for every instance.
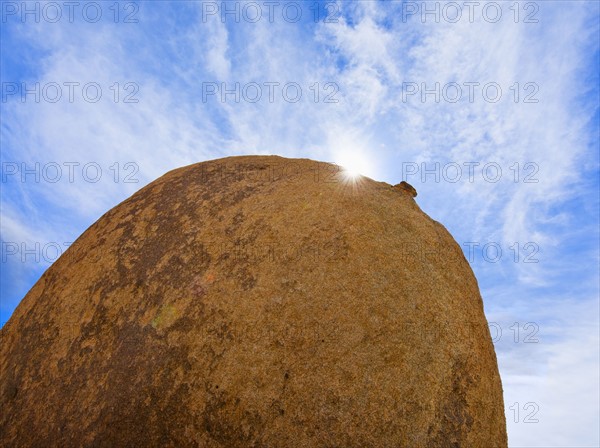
[488,296,600,447]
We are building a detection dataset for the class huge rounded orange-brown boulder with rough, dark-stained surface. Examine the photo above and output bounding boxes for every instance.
[0,156,507,448]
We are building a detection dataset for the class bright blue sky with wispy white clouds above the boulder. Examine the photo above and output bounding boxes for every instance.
[0,0,600,447]
